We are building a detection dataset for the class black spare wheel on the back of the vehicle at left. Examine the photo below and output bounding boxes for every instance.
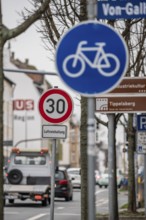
[8,169,23,184]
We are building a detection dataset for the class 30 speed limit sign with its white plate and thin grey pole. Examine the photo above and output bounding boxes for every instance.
[39,88,73,220]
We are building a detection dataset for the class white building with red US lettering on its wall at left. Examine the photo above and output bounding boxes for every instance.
[4,48,51,160]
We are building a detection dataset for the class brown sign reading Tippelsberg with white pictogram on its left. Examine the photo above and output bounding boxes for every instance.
[96,96,146,113]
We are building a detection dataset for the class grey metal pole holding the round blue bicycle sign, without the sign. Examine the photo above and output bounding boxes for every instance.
[87,0,97,220]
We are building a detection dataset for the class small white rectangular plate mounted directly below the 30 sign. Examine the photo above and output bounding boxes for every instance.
[42,125,67,139]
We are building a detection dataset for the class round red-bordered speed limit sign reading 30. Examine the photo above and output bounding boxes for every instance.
[39,88,73,124]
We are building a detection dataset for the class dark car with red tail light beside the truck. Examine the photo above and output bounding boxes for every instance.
[55,167,73,201]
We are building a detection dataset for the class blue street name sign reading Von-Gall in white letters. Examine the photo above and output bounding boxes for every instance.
[97,0,146,20]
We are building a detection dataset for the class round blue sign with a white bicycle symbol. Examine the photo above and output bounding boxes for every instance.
[56,21,129,96]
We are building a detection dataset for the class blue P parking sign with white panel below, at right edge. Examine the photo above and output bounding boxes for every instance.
[137,114,146,154]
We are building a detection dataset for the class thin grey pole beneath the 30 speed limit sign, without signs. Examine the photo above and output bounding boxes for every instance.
[50,139,56,220]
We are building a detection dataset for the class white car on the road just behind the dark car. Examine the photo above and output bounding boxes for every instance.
[67,168,81,188]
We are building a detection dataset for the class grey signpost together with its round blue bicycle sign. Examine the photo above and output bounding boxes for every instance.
[56,0,129,220]
